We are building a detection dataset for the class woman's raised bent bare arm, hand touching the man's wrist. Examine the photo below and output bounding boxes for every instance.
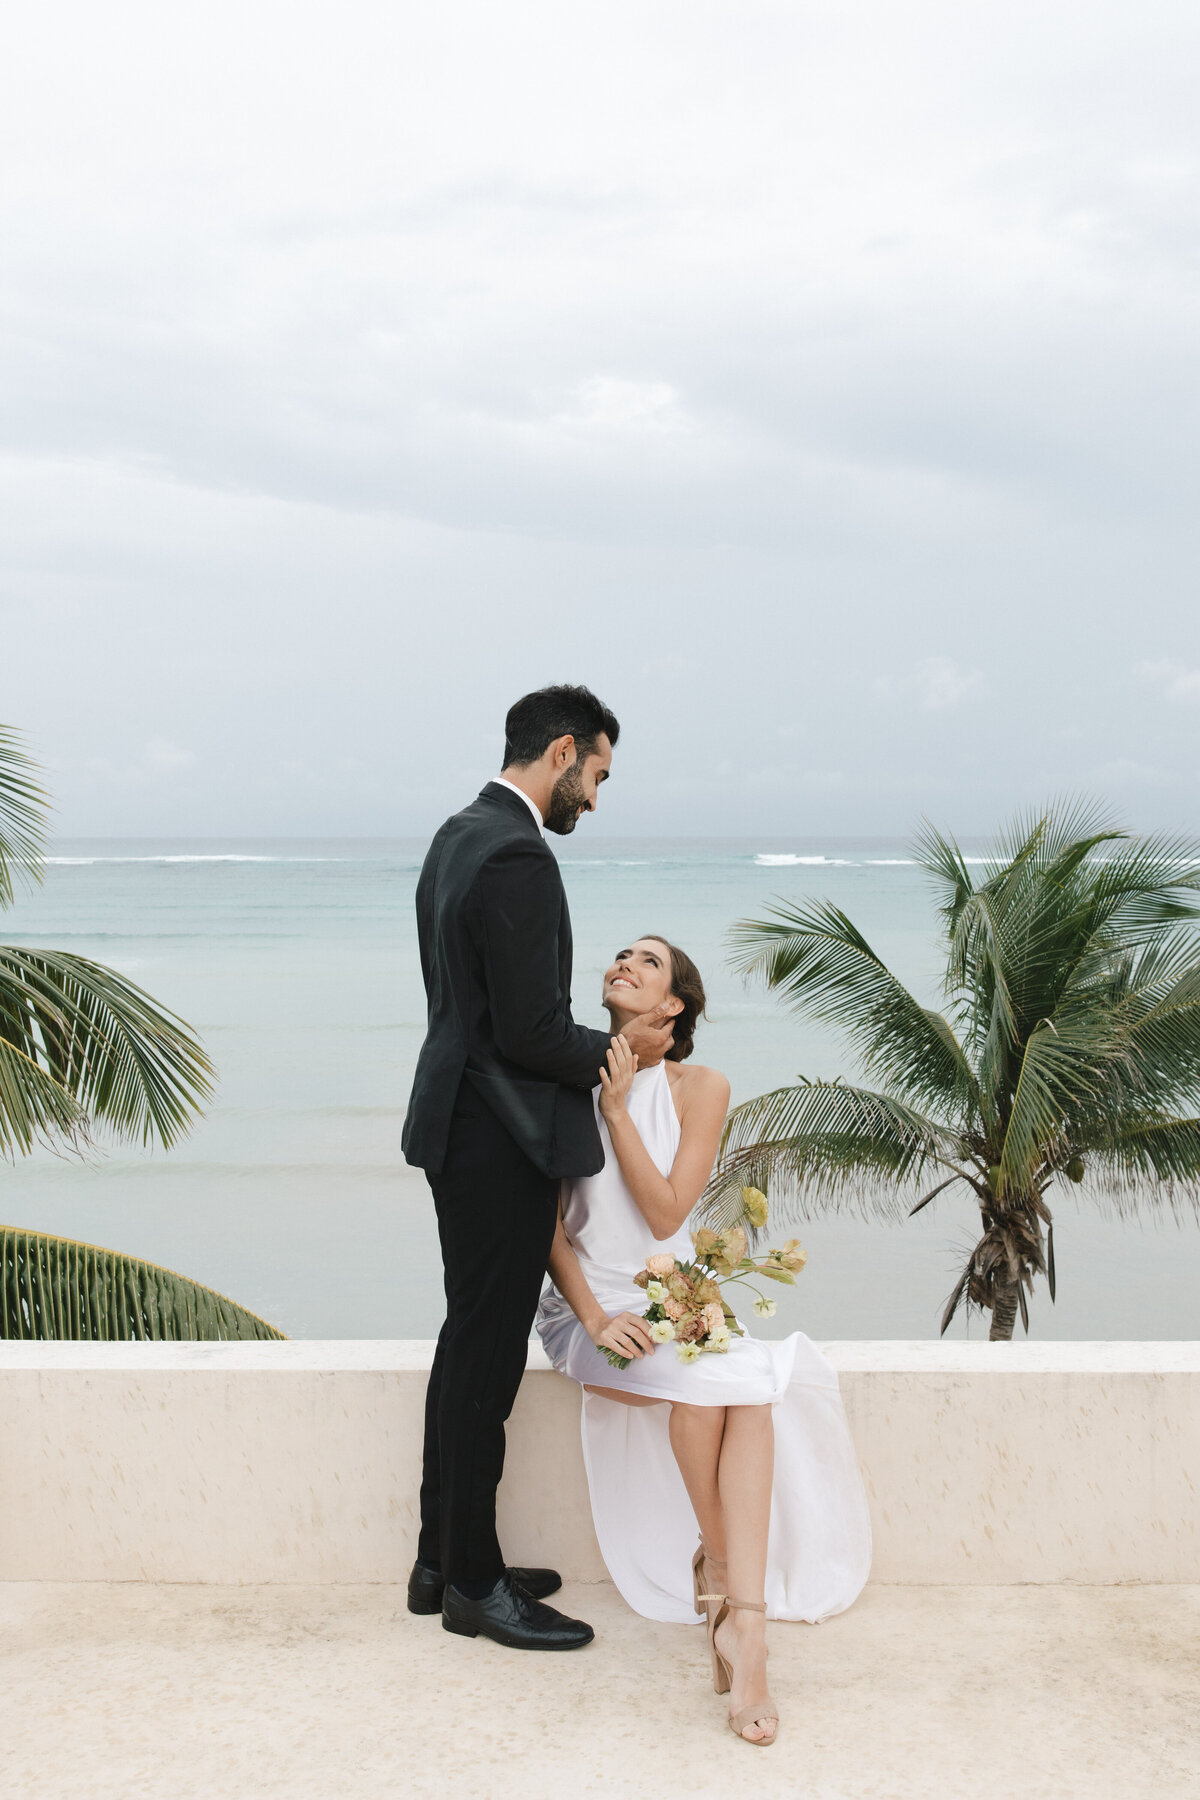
[599,1037,729,1242]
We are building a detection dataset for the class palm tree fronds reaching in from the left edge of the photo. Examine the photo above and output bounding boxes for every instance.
[0,727,282,1339]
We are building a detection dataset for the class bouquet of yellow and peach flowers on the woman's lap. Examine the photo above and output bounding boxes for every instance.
[604,1188,808,1368]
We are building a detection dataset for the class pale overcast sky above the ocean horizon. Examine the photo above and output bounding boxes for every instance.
[0,0,1200,837]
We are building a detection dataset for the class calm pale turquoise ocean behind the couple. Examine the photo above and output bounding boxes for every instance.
[0,838,1200,1339]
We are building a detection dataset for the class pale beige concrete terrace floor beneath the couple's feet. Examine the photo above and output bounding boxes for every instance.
[0,1584,1200,1800]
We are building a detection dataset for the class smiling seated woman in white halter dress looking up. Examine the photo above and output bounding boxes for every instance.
[538,938,871,1744]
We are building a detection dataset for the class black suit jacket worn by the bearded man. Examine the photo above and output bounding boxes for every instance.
[403,783,610,1175]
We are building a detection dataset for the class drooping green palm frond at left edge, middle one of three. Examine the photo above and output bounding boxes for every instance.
[0,945,214,1147]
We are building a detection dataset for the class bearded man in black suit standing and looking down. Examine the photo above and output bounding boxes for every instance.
[403,688,671,1651]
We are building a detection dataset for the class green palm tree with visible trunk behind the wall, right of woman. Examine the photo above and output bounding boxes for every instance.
[709,803,1200,1339]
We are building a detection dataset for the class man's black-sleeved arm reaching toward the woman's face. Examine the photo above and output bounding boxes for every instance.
[479,841,610,1087]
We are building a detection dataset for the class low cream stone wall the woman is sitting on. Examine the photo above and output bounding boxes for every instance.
[0,1339,1200,1584]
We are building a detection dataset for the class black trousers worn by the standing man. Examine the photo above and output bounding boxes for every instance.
[417,1082,558,1586]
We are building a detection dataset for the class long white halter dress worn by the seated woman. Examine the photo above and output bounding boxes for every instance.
[538,1064,871,1624]
